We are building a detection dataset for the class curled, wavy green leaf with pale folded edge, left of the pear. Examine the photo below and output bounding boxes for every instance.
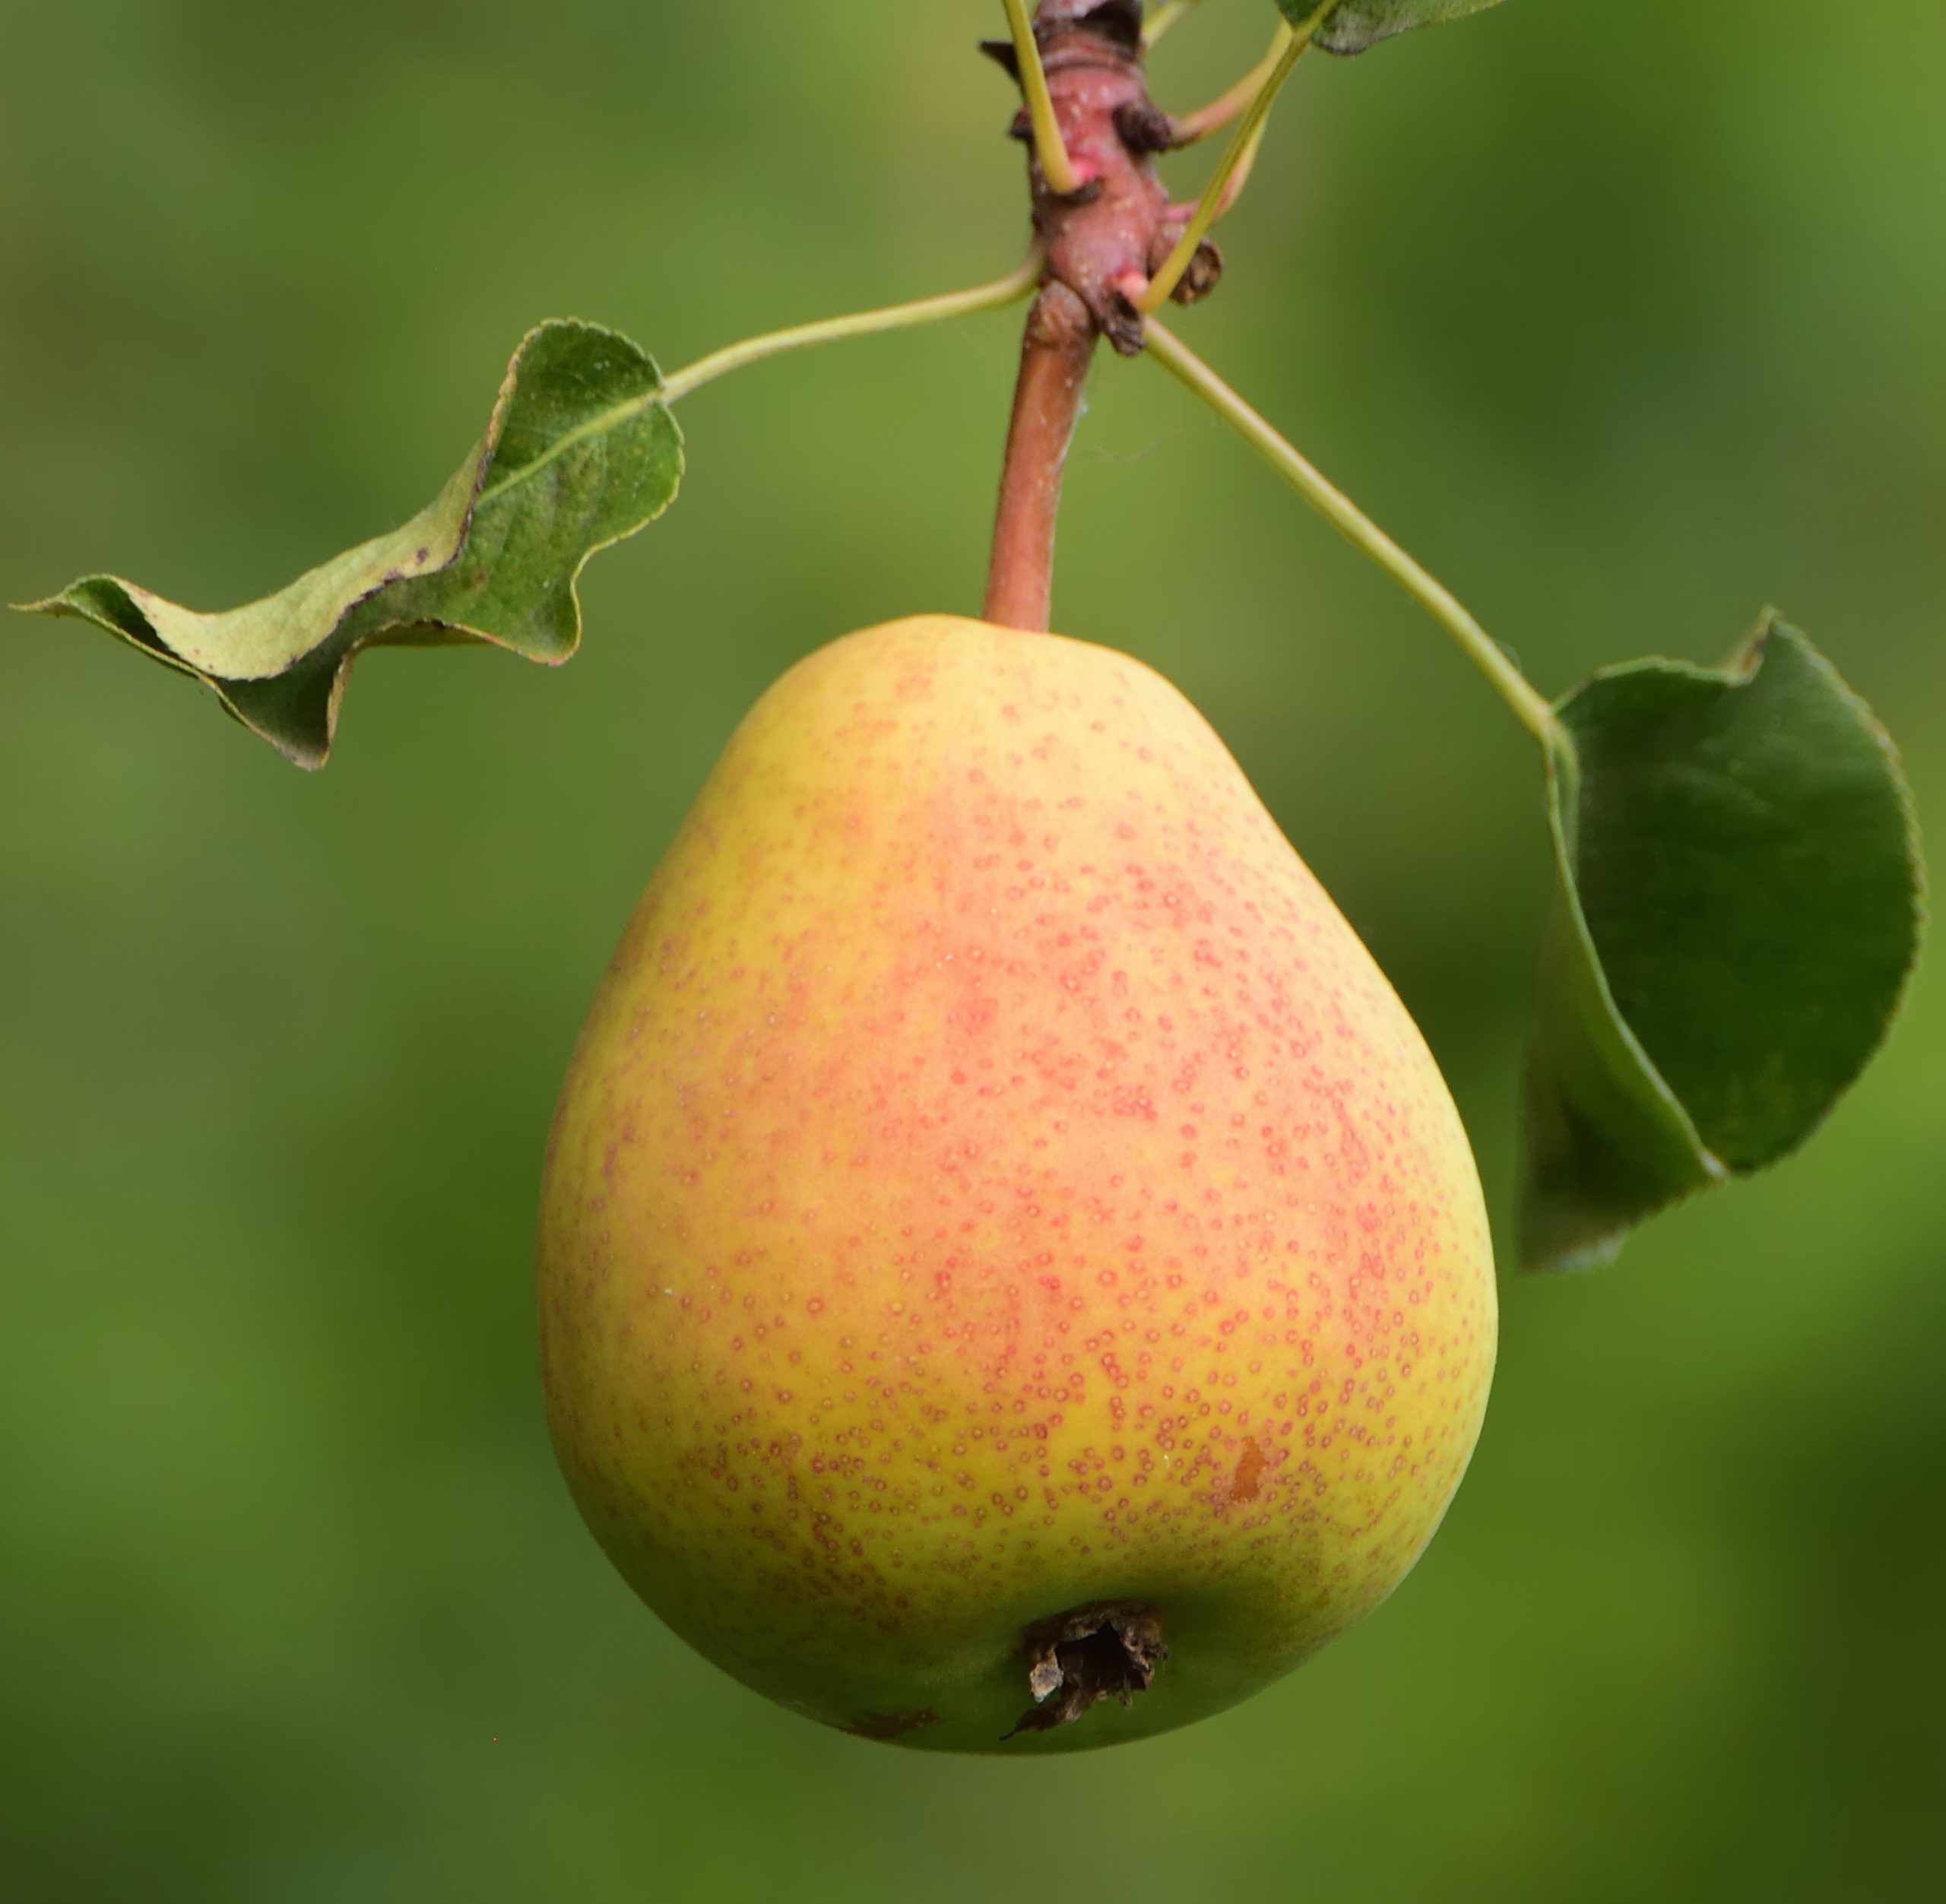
[29,323,683,768]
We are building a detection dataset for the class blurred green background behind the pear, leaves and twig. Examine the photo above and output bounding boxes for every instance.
[0,0,1946,1904]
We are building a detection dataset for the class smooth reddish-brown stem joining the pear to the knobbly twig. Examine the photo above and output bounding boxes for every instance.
[987,284,1101,634]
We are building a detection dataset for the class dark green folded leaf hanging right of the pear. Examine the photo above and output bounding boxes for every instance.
[1522,615,1922,1270]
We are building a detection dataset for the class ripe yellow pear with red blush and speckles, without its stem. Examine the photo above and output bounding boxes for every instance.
[539,616,1497,1752]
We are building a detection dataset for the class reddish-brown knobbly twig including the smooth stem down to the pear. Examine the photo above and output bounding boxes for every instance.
[984,0,1222,634]
